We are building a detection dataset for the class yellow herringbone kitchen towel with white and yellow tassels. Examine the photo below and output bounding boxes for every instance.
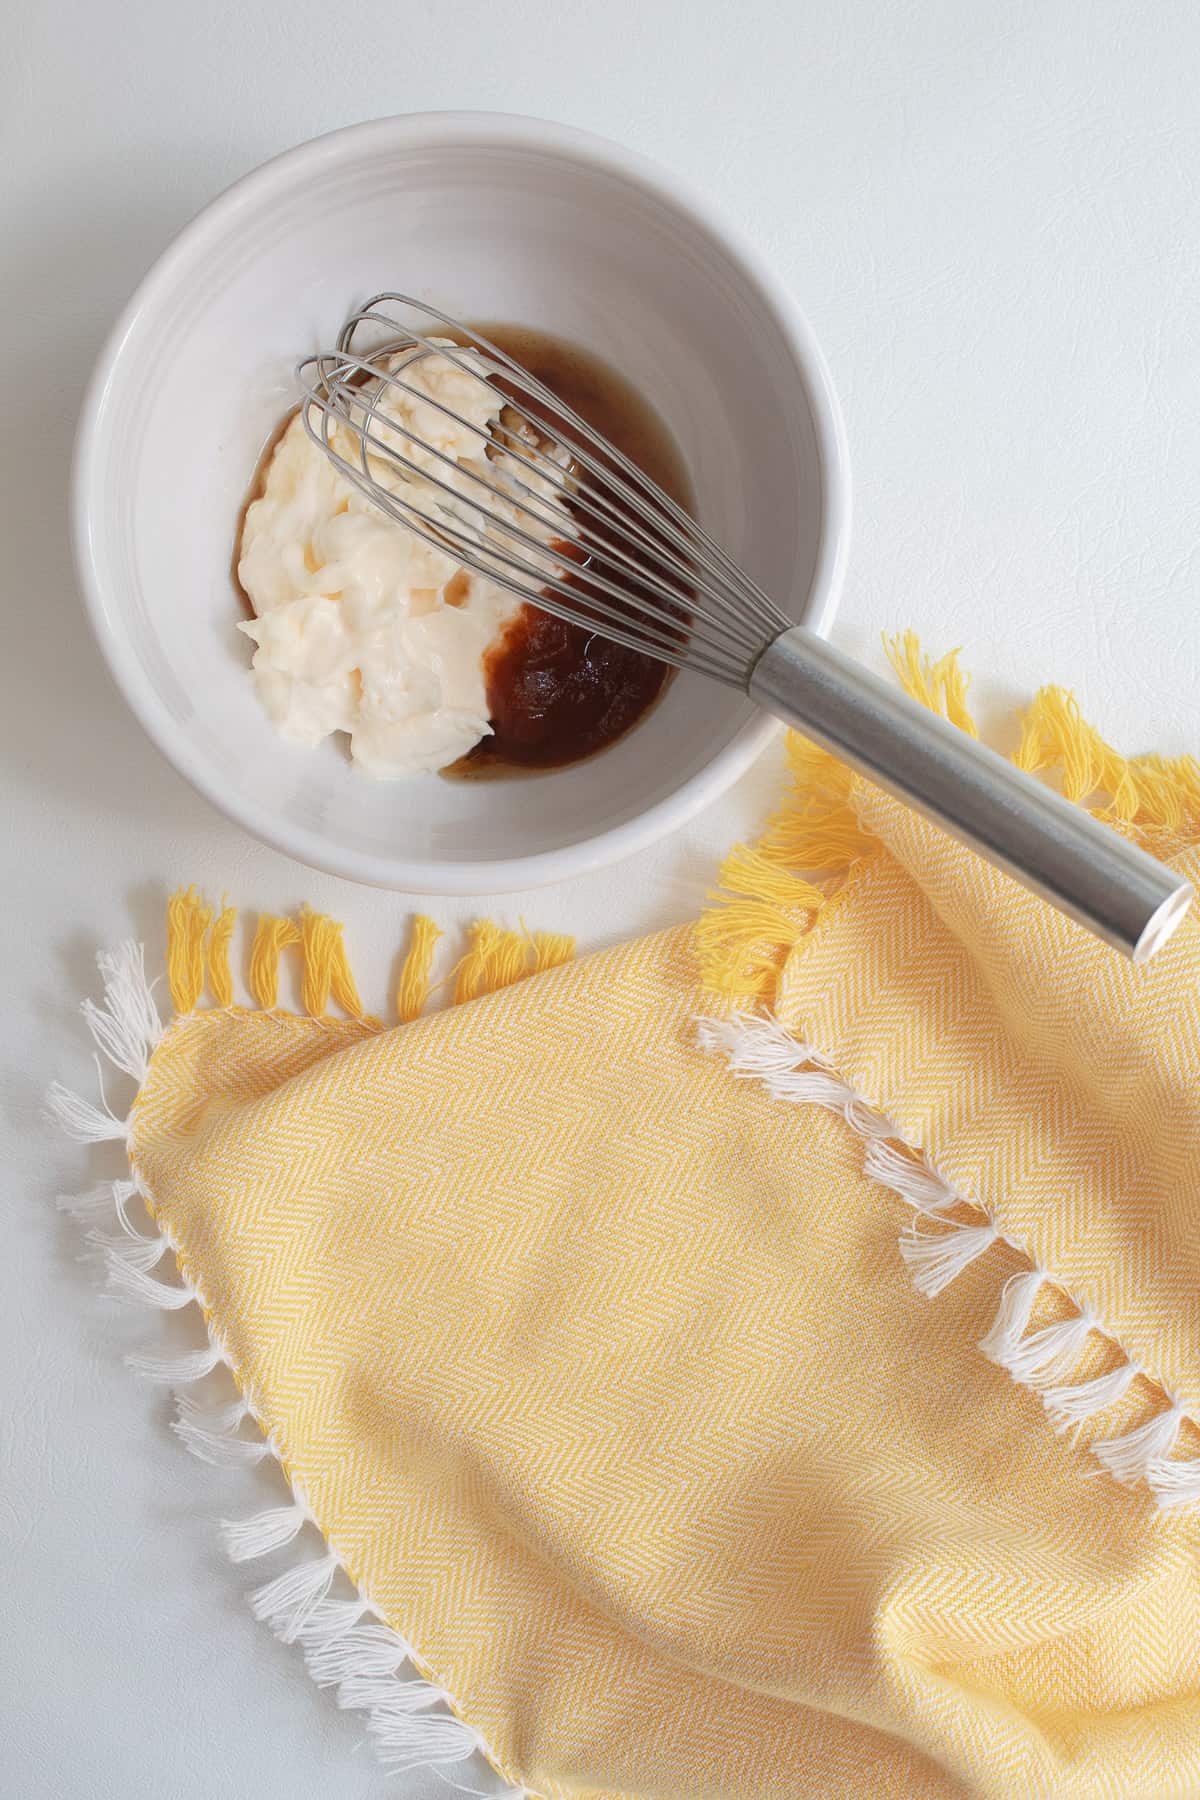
[54,643,1200,1800]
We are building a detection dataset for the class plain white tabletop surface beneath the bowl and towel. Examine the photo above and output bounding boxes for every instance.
[0,0,1200,1800]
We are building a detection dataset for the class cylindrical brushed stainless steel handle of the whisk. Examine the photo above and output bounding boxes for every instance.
[748,626,1195,963]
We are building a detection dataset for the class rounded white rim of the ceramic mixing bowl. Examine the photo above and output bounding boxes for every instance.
[70,110,851,896]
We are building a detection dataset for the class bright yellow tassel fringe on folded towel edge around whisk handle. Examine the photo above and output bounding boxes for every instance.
[694,632,1200,1001]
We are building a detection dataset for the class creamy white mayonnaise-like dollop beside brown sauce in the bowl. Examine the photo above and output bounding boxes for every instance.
[237,351,567,778]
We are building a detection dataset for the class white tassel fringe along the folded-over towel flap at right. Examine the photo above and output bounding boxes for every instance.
[696,1012,1200,1508]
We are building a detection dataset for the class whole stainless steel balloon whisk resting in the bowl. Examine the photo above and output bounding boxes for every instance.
[297,293,1193,961]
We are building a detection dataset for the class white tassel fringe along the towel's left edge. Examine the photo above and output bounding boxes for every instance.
[47,943,529,1800]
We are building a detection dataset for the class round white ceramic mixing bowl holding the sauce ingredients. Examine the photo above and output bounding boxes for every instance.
[74,113,849,895]
